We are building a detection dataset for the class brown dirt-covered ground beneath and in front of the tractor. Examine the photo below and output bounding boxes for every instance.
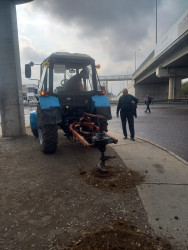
[0,130,171,250]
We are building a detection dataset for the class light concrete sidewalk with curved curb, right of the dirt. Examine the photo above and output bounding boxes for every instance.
[109,131,188,249]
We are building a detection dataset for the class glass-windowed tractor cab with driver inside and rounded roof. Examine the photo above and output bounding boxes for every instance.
[40,52,101,95]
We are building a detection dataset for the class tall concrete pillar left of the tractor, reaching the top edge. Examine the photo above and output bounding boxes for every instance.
[0,0,25,137]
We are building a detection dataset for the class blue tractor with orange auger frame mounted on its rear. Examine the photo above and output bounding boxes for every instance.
[25,52,117,168]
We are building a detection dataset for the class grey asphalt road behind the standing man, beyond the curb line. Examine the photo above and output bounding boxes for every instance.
[108,104,188,161]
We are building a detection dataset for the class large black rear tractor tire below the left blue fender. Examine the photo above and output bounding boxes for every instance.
[38,124,58,154]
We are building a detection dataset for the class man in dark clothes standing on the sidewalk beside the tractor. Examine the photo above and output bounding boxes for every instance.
[116,88,138,141]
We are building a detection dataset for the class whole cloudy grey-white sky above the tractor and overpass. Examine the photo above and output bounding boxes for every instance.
[16,0,188,94]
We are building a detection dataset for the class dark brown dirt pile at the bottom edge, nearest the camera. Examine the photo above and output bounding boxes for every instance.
[70,220,172,250]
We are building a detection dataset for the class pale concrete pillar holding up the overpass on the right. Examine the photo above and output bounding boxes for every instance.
[168,76,181,99]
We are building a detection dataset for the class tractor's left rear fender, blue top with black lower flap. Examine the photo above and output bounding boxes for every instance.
[37,96,62,128]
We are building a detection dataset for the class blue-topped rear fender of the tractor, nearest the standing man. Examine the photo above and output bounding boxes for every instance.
[91,95,112,120]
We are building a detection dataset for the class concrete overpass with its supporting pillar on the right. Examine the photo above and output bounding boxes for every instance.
[133,10,188,99]
